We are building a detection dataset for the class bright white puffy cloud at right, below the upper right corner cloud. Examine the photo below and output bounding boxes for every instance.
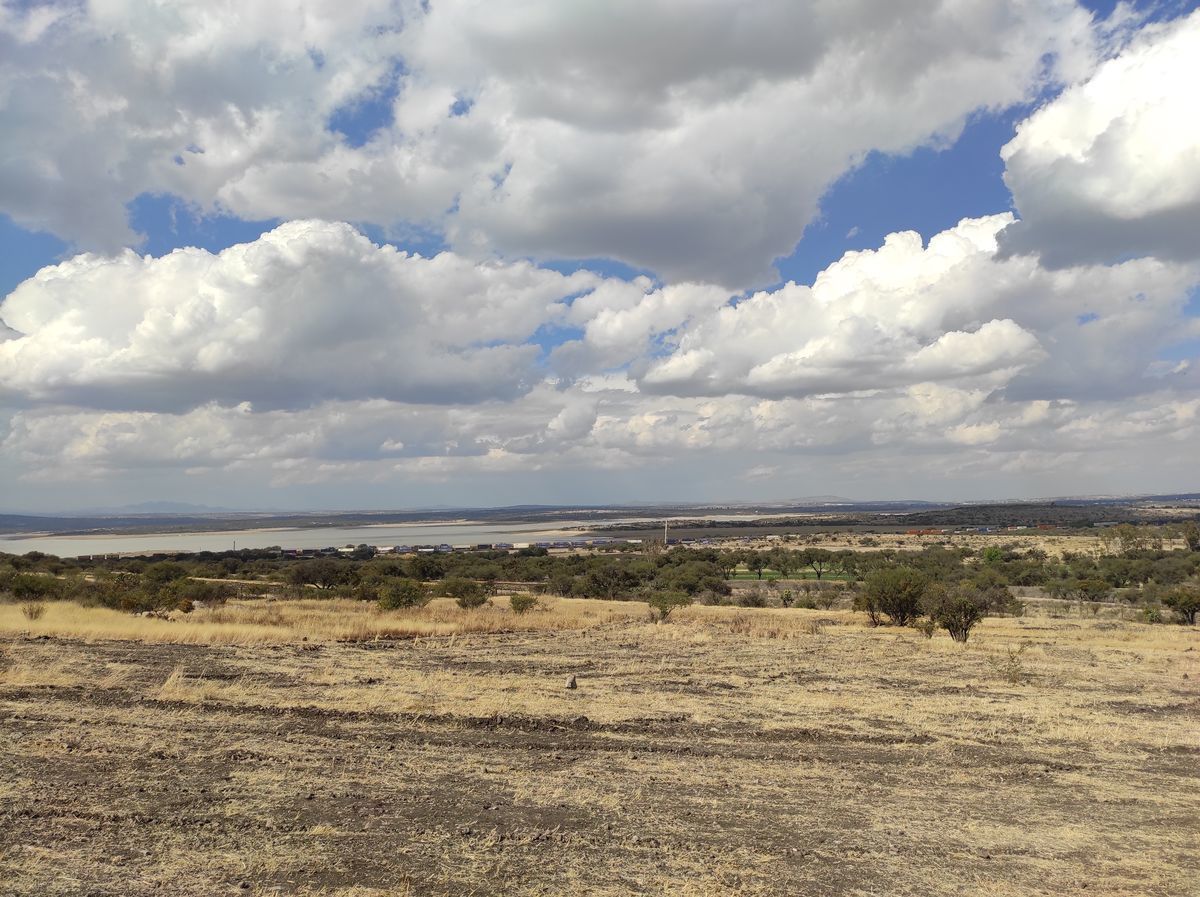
[635,215,1198,399]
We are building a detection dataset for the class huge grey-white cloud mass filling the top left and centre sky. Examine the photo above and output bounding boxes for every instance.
[0,0,1092,288]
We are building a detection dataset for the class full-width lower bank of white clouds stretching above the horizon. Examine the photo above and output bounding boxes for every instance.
[0,215,1200,494]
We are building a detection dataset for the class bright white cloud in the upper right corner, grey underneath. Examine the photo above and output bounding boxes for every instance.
[1001,11,1200,267]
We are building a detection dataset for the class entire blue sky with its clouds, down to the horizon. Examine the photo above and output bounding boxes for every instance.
[0,0,1200,512]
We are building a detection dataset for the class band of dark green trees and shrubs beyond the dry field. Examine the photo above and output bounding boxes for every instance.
[0,523,1200,623]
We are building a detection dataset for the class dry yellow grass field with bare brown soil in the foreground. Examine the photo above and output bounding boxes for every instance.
[0,601,1200,897]
